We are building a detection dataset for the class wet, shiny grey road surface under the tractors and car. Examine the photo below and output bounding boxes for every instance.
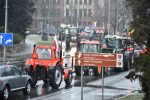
[0,35,141,100]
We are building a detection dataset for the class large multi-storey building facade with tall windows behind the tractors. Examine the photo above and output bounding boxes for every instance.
[31,0,103,30]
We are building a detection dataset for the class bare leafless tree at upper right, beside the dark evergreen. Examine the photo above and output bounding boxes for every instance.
[104,0,131,34]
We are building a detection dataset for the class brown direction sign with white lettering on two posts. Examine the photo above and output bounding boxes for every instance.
[75,52,123,67]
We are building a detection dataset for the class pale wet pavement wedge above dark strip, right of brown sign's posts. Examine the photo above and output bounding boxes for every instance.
[88,71,142,91]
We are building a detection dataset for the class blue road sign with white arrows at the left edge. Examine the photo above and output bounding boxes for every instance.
[0,33,13,46]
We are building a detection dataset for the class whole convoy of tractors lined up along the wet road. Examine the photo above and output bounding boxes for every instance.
[25,26,133,88]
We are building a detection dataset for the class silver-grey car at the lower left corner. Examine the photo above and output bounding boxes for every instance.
[0,65,31,100]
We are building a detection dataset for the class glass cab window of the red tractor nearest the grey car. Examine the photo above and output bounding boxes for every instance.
[36,48,51,60]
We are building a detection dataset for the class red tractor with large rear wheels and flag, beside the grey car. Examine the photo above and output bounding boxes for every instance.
[25,38,72,88]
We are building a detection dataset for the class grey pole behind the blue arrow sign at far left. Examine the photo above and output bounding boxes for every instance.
[3,0,8,65]
